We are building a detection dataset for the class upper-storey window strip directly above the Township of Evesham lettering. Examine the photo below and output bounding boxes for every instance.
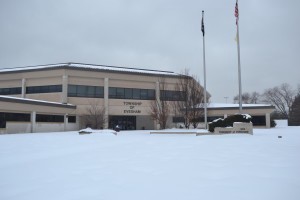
[109,87,155,100]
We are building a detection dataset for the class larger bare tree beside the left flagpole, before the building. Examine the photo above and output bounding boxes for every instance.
[174,69,209,128]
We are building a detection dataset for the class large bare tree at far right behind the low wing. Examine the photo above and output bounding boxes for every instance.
[263,83,295,119]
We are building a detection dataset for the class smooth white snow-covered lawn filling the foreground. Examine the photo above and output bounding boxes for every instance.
[0,123,300,200]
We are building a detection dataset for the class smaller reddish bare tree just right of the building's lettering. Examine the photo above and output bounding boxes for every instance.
[149,77,170,129]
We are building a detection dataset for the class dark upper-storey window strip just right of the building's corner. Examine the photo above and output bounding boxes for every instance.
[68,85,104,98]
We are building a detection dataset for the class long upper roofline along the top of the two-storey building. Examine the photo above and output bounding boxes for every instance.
[0,62,182,77]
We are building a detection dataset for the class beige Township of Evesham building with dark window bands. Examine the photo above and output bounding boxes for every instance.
[0,63,273,133]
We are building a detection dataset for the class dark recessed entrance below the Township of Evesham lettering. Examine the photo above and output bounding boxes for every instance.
[109,116,136,130]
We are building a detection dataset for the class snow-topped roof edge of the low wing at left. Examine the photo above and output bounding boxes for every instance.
[0,96,76,109]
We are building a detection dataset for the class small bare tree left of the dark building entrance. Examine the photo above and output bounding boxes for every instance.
[82,100,107,129]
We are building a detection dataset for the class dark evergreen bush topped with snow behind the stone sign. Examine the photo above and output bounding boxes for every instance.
[208,114,252,132]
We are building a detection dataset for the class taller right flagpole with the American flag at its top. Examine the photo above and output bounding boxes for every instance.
[235,0,243,114]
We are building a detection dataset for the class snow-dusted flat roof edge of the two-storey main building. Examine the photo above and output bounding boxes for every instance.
[0,62,182,76]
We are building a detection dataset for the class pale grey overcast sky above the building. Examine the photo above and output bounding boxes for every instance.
[0,0,300,103]
